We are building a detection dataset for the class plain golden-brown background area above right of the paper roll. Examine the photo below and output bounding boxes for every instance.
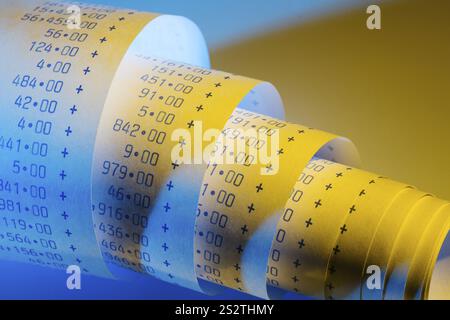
[212,0,450,199]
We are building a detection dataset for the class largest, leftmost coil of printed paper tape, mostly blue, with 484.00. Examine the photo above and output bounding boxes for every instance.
[0,1,207,275]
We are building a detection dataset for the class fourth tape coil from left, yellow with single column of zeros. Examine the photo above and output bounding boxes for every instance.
[269,159,377,298]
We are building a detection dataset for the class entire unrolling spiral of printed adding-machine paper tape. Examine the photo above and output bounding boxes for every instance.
[0,1,450,299]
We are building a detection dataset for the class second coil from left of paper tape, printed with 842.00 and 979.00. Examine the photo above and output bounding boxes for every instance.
[93,54,280,290]
